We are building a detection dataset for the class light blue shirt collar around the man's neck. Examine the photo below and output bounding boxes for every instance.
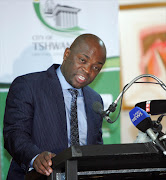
[56,66,83,96]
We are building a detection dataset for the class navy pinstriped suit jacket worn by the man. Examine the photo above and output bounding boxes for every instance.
[4,65,103,180]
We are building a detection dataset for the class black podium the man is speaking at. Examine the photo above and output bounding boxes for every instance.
[25,142,166,180]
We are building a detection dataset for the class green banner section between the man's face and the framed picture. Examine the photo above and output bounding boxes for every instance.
[90,57,121,144]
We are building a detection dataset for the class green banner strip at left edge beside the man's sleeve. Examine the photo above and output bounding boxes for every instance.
[0,89,11,180]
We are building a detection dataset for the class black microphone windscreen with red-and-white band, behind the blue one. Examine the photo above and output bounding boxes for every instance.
[135,99,166,115]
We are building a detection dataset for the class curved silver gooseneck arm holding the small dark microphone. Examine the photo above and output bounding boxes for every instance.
[105,74,166,123]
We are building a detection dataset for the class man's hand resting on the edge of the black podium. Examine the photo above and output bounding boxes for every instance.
[33,151,55,176]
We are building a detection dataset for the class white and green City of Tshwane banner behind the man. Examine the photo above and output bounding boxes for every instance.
[0,0,120,180]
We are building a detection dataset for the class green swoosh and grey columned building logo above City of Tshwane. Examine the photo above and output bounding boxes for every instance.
[33,0,83,33]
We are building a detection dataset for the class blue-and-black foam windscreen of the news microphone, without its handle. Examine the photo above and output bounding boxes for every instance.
[129,107,152,132]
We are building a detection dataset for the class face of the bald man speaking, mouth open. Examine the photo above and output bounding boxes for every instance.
[61,40,105,88]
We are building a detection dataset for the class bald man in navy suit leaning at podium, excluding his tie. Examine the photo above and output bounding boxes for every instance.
[4,34,106,180]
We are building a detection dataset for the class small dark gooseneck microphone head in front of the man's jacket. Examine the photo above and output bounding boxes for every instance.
[93,101,111,123]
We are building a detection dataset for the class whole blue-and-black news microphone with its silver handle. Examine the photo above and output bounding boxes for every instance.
[129,107,166,155]
